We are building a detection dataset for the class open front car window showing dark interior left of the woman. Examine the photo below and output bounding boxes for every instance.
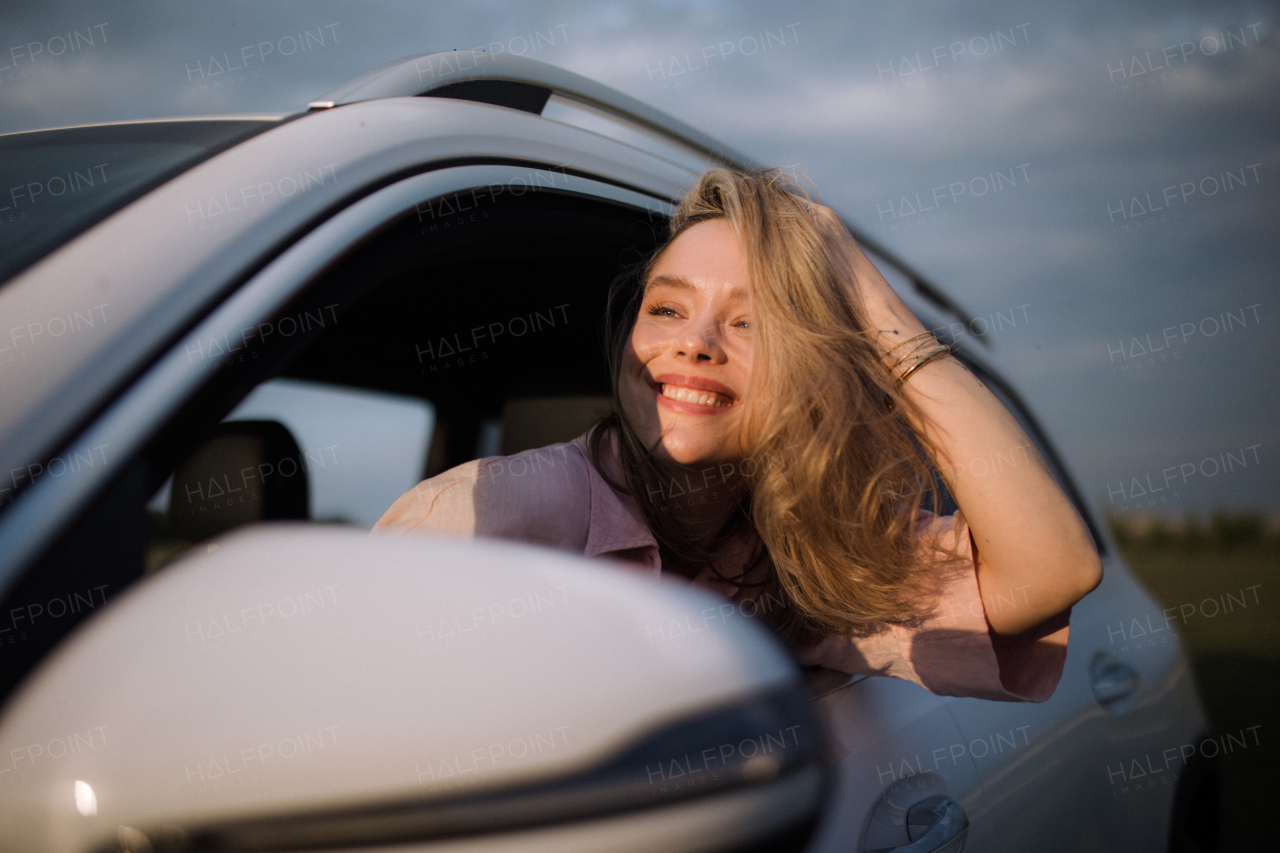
[138,185,655,571]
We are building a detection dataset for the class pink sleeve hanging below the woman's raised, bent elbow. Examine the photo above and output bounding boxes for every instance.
[796,511,1071,702]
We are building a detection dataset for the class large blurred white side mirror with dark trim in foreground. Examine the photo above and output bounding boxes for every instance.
[0,523,827,853]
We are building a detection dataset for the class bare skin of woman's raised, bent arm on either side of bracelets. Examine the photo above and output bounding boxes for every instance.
[809,202,1102,635]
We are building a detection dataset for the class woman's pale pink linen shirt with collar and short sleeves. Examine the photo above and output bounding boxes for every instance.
[374,435,1071,702]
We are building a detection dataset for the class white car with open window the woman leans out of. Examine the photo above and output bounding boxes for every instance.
[0,51,1215,853]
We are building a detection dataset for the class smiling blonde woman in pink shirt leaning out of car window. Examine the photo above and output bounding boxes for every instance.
[375,169,1102,702]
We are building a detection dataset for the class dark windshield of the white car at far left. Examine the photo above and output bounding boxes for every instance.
[0,119,278,282]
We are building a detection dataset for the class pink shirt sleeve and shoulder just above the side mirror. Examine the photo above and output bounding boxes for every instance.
[374,444,591,551]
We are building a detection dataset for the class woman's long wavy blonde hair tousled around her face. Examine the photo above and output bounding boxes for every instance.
[590,169,940,643]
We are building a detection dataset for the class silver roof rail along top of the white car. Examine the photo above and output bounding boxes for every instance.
[307,50,989,346]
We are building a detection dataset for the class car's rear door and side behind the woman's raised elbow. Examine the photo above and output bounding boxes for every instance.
[870,242,1216,850]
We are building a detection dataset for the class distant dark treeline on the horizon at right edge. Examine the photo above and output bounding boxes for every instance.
[1107,512,1280,551]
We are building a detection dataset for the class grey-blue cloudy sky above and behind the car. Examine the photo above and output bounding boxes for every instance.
[0,0,1280,512]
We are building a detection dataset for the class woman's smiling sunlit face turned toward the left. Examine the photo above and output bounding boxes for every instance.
[620,212,754,466]
